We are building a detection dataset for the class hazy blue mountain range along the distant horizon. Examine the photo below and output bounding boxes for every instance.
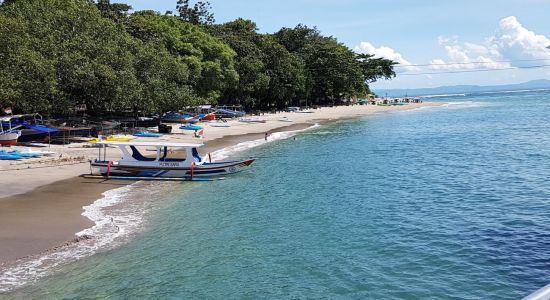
[374,79,550,97]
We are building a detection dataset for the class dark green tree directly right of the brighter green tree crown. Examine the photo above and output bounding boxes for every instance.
[207,19,305,109]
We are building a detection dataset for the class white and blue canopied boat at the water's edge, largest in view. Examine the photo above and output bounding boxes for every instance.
[90,142,254,178]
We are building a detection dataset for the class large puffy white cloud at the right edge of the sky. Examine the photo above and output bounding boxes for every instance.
[430,16,550,70]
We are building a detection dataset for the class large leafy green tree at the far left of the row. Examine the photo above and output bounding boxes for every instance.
[0,0,138,114]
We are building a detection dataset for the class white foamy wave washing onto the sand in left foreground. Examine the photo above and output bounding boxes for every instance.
[0,183,164,292]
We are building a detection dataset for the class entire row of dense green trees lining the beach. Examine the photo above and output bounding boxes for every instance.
[0,0,395,115]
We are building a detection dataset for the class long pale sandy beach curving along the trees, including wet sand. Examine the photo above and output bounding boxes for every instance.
[0,103,441,265]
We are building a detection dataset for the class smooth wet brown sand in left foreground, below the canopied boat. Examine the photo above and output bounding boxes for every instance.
[0,177,127,263]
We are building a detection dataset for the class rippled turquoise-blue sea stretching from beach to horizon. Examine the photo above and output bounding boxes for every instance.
[0,91,550,299]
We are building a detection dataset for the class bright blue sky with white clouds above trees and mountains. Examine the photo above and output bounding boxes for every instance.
[125,0,550,89]
